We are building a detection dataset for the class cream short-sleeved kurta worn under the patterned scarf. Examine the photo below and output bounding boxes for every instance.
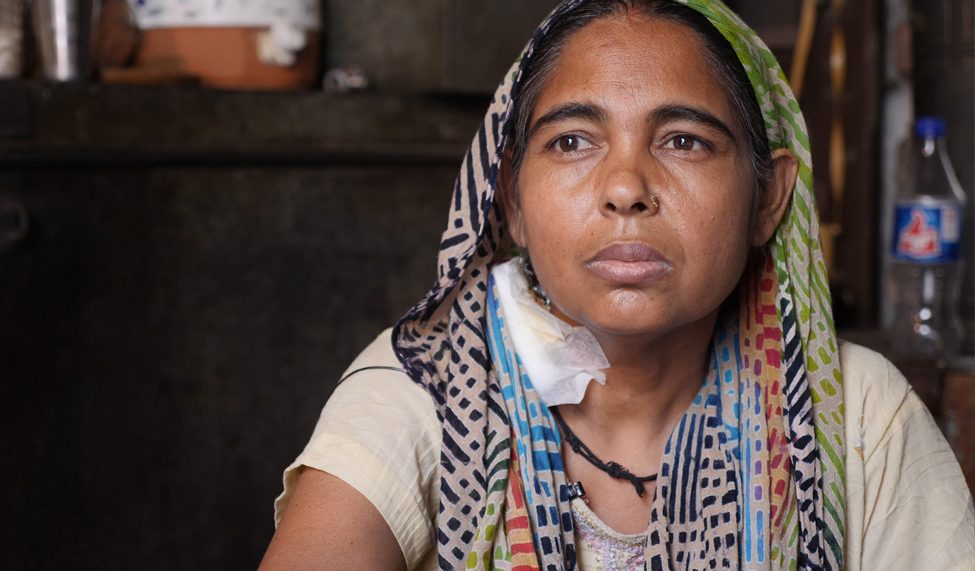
[274,330,975,571]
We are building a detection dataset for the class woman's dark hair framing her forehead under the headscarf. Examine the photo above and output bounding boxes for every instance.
[511,0,774,200]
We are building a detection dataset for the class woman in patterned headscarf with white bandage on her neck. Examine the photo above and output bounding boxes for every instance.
[262,0,975,570]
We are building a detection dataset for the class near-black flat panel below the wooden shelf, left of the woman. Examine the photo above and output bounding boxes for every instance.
[0,166,455,569]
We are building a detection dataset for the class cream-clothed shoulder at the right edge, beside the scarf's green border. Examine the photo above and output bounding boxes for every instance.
[839,342,975,571]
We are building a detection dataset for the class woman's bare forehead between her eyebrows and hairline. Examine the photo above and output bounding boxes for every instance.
[532,17,737,132]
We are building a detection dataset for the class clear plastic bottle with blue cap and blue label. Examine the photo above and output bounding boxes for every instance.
[890,117,965,359]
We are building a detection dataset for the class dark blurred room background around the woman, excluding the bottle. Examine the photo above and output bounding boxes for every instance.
[0,0,975,570]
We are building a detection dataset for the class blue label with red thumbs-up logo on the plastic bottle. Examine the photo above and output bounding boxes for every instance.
[893,204,961,264]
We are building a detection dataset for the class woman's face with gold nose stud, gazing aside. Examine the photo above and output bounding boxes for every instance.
[511,17,754,337]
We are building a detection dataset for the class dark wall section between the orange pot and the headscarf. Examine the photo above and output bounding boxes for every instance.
[324,0,559,93]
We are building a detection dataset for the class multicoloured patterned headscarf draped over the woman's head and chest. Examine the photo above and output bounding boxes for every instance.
[393,0,845,571]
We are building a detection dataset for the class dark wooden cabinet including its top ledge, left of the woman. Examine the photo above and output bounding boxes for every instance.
[0,82,486,571]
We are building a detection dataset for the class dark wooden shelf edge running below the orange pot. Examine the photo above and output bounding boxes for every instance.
[0,81,487,166]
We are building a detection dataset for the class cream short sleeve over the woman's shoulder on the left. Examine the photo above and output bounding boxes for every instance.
[275,329,440,569]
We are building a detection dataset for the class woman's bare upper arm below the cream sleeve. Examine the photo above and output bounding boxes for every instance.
[259,468,406,571]
